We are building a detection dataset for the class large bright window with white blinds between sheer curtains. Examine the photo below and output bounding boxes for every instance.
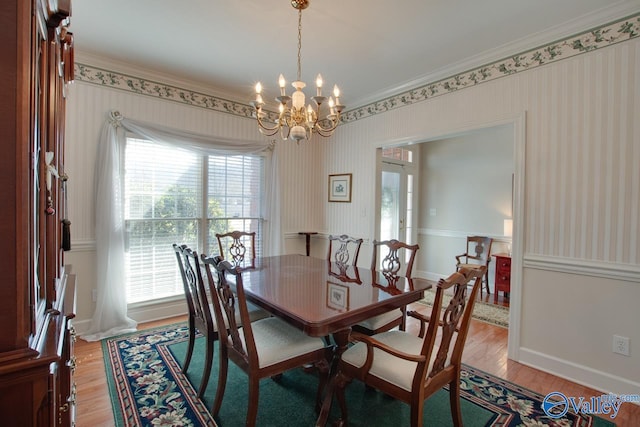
[124,138,264,304]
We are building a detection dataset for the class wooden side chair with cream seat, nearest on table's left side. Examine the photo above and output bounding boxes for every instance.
[202,256,333,426]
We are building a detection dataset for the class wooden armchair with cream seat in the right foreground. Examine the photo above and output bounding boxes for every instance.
[330,266,486,427]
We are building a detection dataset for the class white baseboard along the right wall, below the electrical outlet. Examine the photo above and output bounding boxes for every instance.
[518,347,640,397]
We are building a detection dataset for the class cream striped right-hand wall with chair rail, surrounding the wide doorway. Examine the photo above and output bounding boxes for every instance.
[316,40,640,393]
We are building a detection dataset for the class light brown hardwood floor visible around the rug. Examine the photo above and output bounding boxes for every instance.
[75,310,640,427]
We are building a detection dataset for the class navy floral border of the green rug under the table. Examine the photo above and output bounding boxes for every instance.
[102,322,615,427]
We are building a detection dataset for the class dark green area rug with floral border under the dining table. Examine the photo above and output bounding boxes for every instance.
[102,323,614,427]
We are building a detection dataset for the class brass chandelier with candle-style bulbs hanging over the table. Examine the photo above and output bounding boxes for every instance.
[251,0,344,143]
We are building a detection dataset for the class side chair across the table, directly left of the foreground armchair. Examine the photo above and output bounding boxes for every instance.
[353,239,420,335]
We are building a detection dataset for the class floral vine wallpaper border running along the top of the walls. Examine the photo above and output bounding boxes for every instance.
[75,12,640,123]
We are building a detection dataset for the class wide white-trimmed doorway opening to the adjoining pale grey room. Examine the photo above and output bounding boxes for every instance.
[375,114,525,360]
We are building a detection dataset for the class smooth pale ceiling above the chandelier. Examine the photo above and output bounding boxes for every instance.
[71,0,640,110]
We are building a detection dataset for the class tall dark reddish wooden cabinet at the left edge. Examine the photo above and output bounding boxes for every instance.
[0,0,75,427]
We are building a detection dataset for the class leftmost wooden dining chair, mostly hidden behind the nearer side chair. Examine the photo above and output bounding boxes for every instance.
[173,243,269,397]
